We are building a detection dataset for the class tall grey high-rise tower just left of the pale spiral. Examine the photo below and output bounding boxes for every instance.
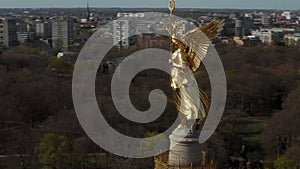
[52,19,73,52]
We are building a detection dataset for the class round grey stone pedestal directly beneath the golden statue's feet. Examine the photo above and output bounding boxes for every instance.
[168,131,202,168]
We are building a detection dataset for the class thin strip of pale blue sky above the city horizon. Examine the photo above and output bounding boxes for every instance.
[0,0,300,10]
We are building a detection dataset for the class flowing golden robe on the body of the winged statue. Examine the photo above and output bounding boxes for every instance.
[169,49,206,129]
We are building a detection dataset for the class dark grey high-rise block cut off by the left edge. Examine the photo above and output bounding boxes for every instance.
[0,18,18,47]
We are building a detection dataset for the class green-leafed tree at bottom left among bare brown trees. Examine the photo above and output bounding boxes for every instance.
[36,133,71,169]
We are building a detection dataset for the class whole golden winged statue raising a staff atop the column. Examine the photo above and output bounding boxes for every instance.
[165,0,224,133]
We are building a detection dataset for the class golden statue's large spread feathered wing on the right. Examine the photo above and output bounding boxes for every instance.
[183,20,224,71]
